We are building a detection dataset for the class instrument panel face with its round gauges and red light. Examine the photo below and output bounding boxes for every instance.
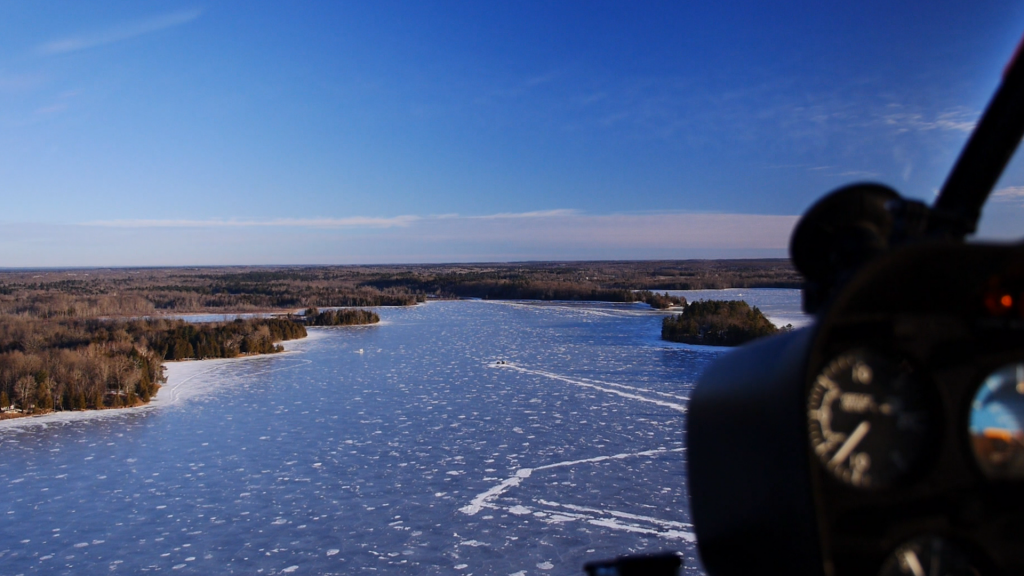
[804,239,1024,576]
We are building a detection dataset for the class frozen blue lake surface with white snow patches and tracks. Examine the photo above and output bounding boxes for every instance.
[0,290,799,576]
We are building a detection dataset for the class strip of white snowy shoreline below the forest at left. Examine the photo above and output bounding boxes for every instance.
[0,330,326,434]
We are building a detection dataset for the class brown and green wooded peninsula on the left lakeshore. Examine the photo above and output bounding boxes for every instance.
[0,316,306,419]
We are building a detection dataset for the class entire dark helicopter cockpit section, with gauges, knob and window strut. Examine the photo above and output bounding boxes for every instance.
[588,29,1024,576]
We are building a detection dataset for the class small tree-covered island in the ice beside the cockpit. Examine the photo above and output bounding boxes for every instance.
[662,300,792,346]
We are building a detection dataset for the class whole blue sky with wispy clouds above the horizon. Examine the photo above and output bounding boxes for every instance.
[0,1,1024,266]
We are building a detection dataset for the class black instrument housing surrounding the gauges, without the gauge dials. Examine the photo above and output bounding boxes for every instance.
[687,241,1024,576]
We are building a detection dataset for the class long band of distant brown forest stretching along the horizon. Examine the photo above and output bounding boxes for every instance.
[0,259,801,318]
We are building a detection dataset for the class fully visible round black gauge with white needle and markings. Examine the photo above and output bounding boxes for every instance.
[807,349,931,489]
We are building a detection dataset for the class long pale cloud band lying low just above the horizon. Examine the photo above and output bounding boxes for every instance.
[12,210,798,266]
